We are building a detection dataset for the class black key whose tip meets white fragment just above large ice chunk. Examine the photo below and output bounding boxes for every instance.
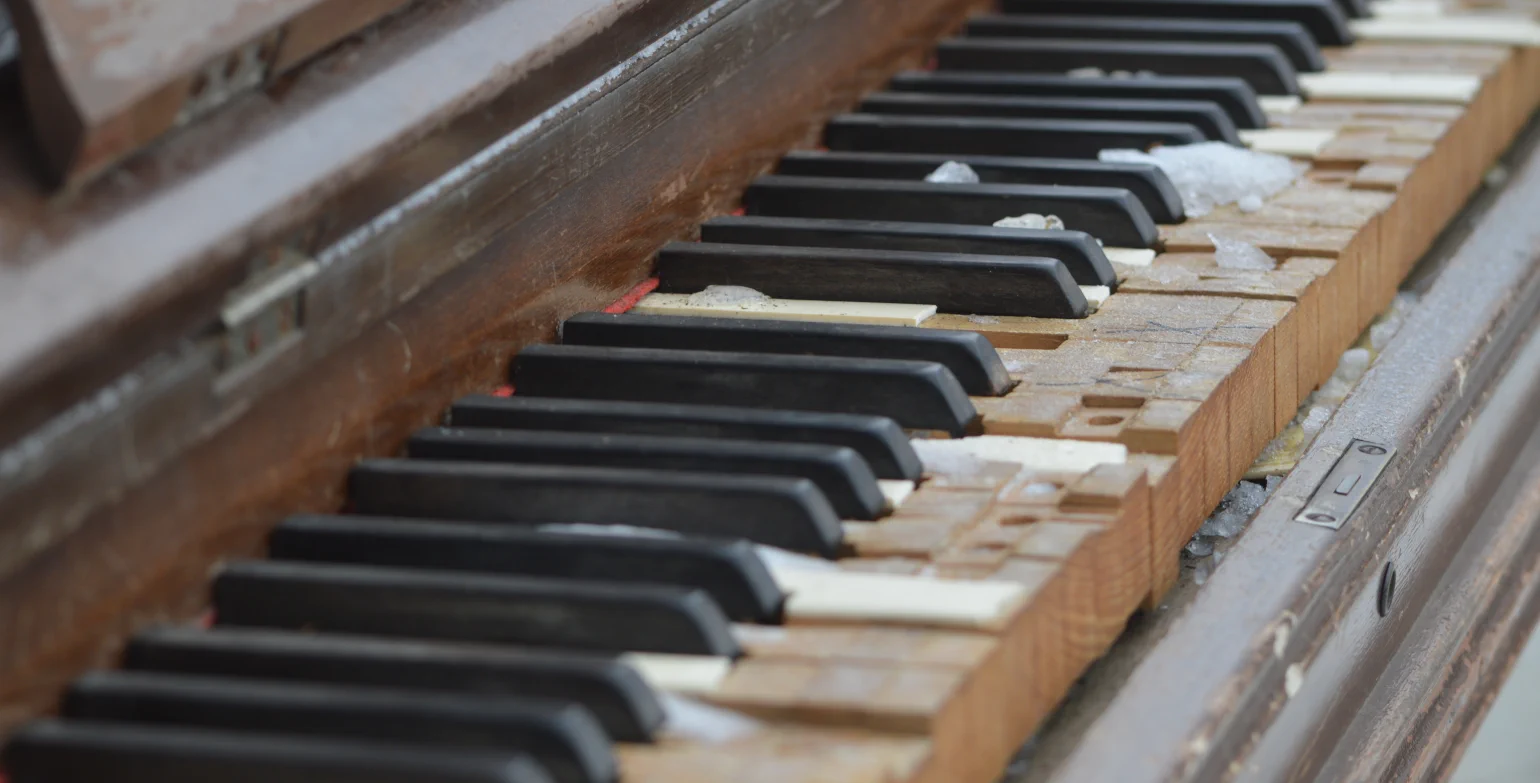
[856,92,1241,145]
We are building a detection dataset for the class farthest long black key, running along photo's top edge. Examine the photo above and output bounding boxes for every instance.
[1001,0,1357,46]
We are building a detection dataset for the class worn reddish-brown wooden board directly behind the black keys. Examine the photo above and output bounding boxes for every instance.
[0,0,979,728]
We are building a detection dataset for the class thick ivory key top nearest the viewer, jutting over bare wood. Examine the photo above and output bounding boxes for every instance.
[772,569,1027,630]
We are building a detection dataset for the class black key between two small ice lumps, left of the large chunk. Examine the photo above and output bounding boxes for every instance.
[742,174,1160,243]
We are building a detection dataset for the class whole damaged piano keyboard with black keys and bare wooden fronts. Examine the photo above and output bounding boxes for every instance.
[3,0,1540,783]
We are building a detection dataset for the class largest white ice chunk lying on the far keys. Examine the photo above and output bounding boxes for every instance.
[1098,142,1303,217]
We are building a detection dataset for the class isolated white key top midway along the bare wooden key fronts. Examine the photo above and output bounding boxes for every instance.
[912,435,1129,473]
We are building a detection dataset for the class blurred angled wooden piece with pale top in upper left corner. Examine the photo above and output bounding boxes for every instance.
[9,0,408,185]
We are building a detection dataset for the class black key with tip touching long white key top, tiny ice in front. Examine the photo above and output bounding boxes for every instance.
[936,39,1300,96]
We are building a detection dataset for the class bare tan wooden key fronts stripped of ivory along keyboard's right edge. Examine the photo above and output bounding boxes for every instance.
[637,25,1540,783]
